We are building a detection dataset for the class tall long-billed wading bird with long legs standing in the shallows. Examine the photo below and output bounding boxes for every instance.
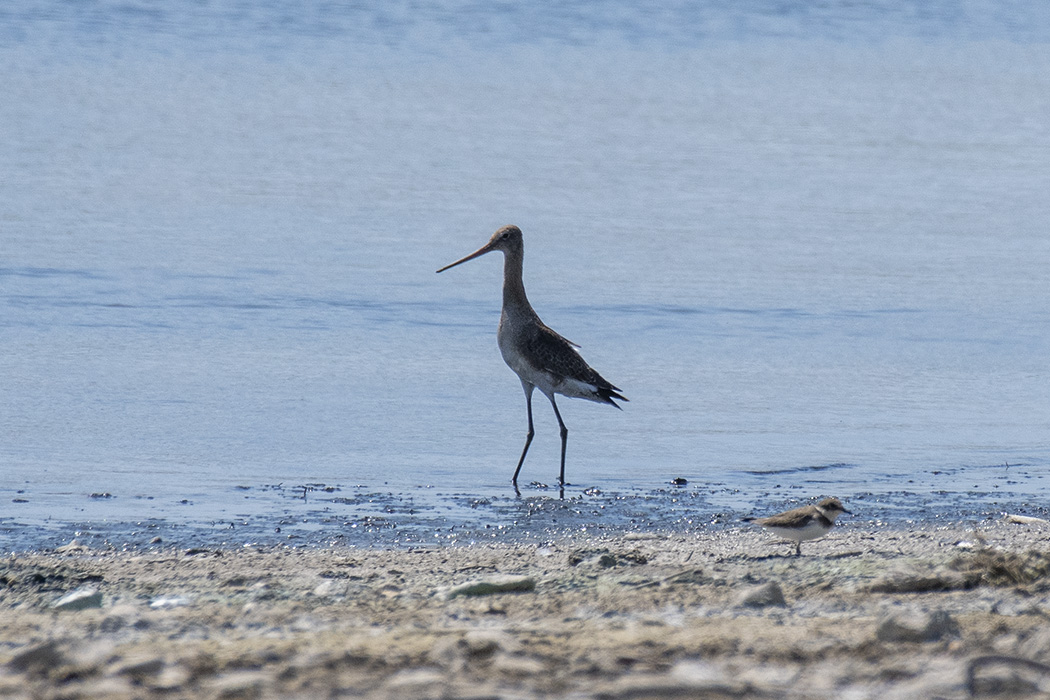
[438,226,627,487]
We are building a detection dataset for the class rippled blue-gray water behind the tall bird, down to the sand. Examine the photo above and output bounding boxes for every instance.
[0,0,1050,550]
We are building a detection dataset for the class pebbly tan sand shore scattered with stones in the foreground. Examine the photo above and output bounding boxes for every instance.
[0,519,1050,700]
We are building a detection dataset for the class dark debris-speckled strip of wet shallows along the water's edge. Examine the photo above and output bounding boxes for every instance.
[0,468,1050,554]
